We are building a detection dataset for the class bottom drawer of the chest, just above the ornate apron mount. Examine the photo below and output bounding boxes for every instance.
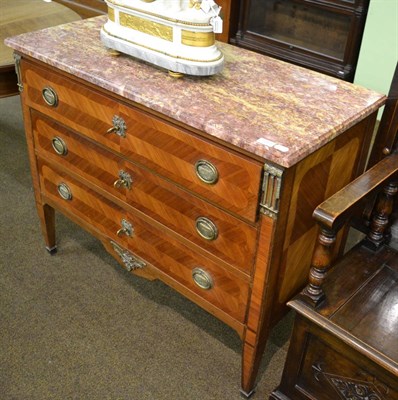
[39,162,249,322]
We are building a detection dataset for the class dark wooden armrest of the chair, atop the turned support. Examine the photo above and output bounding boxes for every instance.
[313,153,398,231]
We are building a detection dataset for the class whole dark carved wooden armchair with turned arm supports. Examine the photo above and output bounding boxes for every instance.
[270,151,398,400]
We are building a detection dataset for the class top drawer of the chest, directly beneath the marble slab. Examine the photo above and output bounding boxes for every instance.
[21,61,262,222]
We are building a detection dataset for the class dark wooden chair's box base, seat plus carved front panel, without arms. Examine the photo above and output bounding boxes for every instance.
[270,244,398,400]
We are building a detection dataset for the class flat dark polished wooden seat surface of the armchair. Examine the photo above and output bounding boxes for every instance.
[289,244,398,376]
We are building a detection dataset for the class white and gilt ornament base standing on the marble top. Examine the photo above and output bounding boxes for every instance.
[101,0,224,75]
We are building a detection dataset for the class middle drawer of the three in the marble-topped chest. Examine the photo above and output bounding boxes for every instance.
[32,112,257,274]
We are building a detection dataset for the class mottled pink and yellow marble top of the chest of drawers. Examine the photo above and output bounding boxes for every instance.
[5,16,385,167]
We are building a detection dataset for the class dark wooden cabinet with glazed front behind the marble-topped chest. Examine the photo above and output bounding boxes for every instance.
[231,0,369,81]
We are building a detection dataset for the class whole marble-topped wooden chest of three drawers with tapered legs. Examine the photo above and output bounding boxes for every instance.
[8,17,384,395]
